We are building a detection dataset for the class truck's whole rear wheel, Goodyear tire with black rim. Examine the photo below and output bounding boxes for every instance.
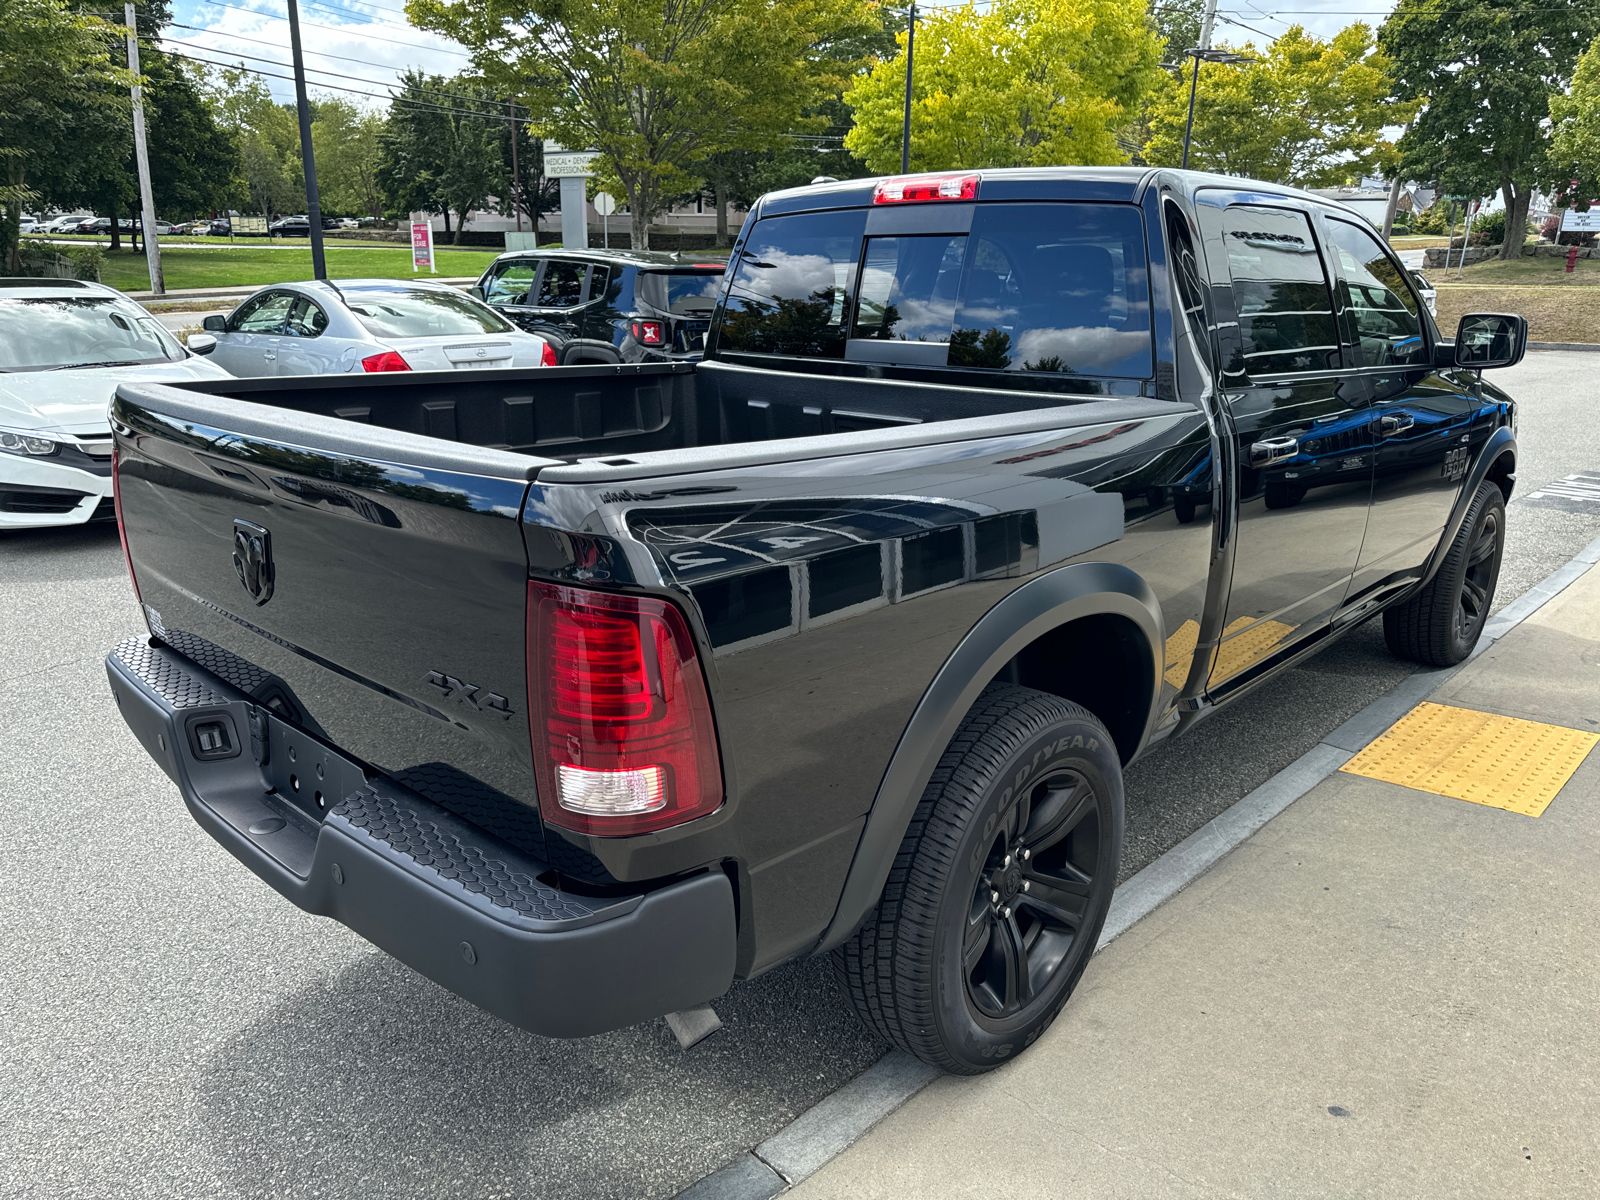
[834,683,1123,1075]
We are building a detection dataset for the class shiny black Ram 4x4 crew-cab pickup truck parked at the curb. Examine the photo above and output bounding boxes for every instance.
[107,168,1526,1072]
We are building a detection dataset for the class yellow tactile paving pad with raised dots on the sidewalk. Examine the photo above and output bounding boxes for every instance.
[1342,704,1600,816]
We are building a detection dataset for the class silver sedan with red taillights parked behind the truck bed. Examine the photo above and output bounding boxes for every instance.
[202,278,555,376]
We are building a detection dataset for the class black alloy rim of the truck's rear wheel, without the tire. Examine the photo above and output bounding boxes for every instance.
[962,771,1099,1018]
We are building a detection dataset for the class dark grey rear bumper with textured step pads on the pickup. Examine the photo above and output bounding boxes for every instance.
[106,638,734,1037]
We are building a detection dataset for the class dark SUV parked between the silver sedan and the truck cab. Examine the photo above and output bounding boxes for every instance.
[477,250,725,366]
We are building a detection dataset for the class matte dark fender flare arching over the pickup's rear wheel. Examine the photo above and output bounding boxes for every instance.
[816,563,1166,954]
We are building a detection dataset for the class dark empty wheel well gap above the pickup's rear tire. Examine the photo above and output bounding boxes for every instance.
[995,613,1155,763]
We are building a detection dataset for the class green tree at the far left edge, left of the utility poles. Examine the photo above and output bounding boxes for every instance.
[0,0,133,272]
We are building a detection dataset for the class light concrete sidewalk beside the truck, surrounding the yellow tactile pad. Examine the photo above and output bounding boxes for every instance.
[787,568,1600,1200]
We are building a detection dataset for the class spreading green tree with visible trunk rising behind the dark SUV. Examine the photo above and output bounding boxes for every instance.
[406,0,877,250]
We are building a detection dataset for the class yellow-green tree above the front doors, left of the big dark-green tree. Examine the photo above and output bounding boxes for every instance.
[1144,24,1408,187]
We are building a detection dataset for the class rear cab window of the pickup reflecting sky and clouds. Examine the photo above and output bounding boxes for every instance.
[720,202,1154,379]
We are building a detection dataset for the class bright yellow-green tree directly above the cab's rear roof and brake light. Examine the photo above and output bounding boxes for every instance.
[845,0,1160,173]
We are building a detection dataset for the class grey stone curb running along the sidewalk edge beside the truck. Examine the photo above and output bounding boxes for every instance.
[675,531,1600,1200]
